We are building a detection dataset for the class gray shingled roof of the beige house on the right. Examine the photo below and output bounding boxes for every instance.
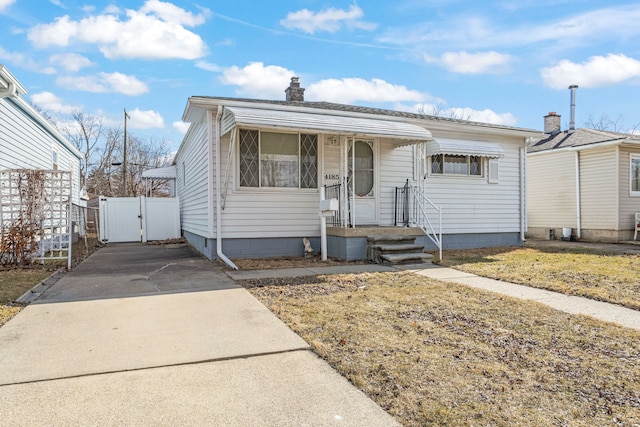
[528,128,640,153]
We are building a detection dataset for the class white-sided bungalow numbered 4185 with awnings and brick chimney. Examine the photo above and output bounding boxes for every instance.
[175,78,544,262]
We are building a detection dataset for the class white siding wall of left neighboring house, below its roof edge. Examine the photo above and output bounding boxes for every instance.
[0,98,80,204]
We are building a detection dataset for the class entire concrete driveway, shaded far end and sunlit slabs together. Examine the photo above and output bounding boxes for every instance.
[0,244,396,426]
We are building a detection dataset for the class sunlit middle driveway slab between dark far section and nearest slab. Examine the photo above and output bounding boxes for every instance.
[0,287,308,385]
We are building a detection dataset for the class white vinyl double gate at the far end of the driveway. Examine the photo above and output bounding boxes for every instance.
[100,196,180,243]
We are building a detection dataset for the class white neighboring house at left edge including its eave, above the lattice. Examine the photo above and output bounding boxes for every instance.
[0,64,84,205]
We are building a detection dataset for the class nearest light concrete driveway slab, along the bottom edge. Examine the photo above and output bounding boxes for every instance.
[0,350,399,427]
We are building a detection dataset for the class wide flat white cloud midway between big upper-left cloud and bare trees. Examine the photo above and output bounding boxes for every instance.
[56,73,149,96]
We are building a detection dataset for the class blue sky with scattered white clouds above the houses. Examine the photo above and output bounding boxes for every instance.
[0,0,640,149]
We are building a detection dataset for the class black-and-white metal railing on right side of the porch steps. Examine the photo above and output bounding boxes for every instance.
[394,180,442,260]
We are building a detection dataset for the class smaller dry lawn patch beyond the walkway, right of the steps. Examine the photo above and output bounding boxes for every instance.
[442,244,640,310]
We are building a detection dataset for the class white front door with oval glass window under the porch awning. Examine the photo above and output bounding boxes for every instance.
[347,139,378,225]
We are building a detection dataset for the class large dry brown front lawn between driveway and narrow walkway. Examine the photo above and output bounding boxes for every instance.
[242,272,640,426]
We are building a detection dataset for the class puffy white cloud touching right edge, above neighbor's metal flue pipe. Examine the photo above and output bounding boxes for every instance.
[540,54,640,89]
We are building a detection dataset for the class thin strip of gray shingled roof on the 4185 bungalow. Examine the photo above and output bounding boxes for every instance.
[197,96,542,133]
